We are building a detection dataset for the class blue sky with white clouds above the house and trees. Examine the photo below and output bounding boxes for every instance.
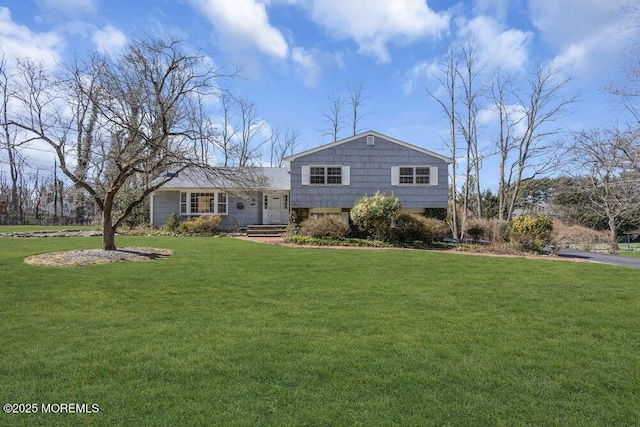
[0,0,640,191]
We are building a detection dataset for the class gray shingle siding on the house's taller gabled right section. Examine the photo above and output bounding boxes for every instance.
[290,134,448,208]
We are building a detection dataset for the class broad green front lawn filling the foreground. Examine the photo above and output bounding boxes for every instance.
[0,237,640,426]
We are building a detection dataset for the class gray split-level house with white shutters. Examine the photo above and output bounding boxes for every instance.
[150,131,452,229]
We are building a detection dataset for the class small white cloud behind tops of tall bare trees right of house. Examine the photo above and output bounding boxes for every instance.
[459,16,531,71]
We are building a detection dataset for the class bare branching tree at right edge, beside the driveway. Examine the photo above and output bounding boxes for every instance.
[561,129,640,253]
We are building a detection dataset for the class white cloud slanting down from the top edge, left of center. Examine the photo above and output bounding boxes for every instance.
[191,0,289,58]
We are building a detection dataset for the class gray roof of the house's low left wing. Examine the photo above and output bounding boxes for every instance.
[159,167,291,191]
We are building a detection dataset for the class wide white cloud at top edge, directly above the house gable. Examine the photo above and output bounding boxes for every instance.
[298,0,449,63]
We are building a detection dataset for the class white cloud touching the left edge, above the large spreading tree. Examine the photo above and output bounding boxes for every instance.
[0,7,63,65]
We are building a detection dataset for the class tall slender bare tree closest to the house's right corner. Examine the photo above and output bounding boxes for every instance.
[426,49,460,239]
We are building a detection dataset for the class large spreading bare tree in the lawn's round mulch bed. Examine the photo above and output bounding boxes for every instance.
[9,38,238,250]
